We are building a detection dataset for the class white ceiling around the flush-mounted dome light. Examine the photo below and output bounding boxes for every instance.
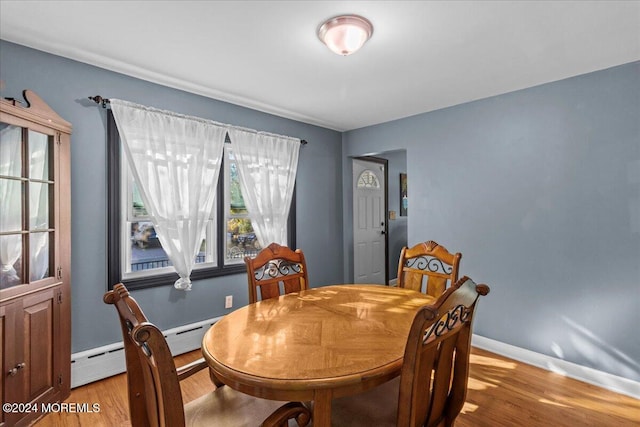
[0,0,640,131]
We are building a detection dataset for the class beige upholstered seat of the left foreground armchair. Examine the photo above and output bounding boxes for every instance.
[184,386,296,427]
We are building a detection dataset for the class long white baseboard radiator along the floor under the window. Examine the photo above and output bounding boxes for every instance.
[71,317,221,388]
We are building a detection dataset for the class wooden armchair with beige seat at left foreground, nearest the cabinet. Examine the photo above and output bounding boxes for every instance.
[104,283,311,427]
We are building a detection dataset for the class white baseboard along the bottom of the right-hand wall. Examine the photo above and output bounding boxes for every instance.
[471,334,640,399]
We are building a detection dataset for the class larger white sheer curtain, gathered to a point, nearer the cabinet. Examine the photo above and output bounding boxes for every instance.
[111,99,227,290]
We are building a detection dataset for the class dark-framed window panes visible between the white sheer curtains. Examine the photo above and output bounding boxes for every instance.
[107,110,295,289]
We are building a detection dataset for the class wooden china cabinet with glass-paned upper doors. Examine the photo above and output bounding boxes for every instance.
[0,90,71,427]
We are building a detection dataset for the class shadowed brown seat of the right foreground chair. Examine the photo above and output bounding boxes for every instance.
[331,377,400,427]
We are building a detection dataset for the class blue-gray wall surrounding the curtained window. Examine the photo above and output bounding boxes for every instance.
[0,41,343,352]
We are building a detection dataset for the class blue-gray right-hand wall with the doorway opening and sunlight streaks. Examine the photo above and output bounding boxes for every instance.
[343,62,640,381]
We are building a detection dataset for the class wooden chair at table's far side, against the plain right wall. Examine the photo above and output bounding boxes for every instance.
[397,240,462,297]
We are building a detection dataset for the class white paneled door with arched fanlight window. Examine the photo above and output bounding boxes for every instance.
[353,159,386,284]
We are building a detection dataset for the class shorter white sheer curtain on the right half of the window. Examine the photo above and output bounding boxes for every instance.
[229,129,300,247]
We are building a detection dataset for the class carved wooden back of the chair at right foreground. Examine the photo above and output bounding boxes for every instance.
[398,276,489,426]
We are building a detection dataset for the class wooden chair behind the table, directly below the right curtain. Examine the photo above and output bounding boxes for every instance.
[244,243,309,303]
